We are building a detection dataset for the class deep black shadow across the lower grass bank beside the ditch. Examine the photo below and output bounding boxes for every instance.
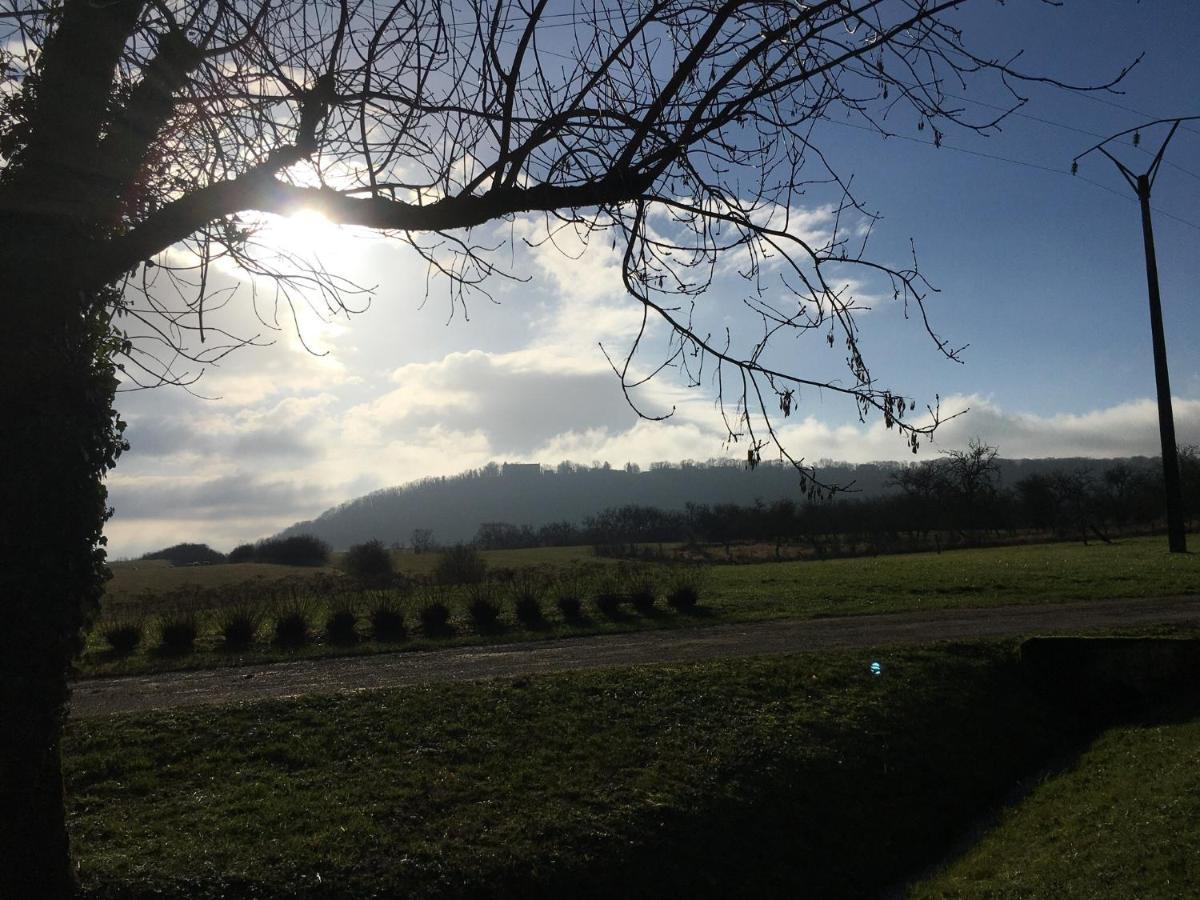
[75,644,1200,898]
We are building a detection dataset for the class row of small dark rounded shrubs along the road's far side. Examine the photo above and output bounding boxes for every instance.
[100,566,703,656]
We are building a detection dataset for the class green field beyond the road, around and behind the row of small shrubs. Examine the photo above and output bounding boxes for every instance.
[87,538,1200,676]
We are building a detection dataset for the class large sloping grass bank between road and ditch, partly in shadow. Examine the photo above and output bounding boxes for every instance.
[72,643,1089,898]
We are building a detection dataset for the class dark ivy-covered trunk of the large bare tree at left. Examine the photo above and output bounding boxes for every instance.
[0,230,121,898]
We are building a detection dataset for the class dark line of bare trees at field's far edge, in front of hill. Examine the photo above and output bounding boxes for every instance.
[473,442,1200,558]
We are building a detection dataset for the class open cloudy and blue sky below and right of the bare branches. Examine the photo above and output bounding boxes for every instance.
[106,0,1200,558]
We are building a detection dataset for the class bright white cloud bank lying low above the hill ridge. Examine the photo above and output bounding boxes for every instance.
[108,353,1200,556]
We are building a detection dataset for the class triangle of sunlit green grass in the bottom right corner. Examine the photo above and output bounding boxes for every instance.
[910,719,1200,900]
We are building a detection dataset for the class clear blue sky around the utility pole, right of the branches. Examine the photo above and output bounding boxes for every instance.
[820,2,1200,414]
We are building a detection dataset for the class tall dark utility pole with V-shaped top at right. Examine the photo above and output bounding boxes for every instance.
[1070,115,1200,553]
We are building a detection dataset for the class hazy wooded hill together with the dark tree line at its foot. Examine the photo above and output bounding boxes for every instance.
[277,444,1200,556]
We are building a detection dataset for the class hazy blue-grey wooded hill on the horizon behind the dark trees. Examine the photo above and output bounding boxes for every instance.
[278,457,1153,550]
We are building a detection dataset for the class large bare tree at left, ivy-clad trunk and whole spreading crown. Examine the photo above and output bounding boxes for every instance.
[0,0,1123,896]
